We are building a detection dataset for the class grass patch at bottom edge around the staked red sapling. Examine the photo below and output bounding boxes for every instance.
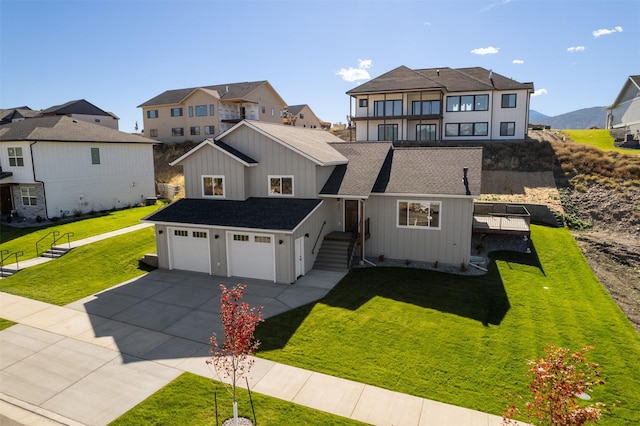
[110,373,362,426]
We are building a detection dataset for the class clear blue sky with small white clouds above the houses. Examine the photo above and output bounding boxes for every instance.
[0,0,640,132]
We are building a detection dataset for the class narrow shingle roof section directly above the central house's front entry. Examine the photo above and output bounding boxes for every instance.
[320,142,393,198]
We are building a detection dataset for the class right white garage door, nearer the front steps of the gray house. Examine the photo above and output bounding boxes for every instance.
[227,232,276,282]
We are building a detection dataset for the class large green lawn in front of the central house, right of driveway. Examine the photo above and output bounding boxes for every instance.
[257,226,640,425]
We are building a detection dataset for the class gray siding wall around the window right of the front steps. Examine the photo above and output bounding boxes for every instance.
[365,196,473,265]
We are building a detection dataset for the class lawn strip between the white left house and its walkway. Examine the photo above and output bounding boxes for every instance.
[0,204,162,263]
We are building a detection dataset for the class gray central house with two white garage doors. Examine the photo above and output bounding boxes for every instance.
[144,121,482,284]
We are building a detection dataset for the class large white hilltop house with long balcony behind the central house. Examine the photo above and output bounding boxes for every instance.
[347,66,533,142]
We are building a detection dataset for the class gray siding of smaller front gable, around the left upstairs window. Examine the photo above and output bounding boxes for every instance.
[182,146,245,200]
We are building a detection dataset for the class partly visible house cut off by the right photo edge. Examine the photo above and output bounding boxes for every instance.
[605,75,640,139]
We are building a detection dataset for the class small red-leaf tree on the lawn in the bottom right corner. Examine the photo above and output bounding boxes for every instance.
[503,345,605,426]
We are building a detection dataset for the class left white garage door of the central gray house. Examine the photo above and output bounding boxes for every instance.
[167,228,211,274]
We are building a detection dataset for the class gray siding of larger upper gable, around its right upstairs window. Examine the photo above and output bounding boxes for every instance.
[224,126,317,198]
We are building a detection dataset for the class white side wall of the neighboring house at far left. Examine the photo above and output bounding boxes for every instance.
[32,142,155,217]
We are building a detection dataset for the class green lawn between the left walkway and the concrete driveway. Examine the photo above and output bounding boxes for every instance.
[0,227,156,306]
